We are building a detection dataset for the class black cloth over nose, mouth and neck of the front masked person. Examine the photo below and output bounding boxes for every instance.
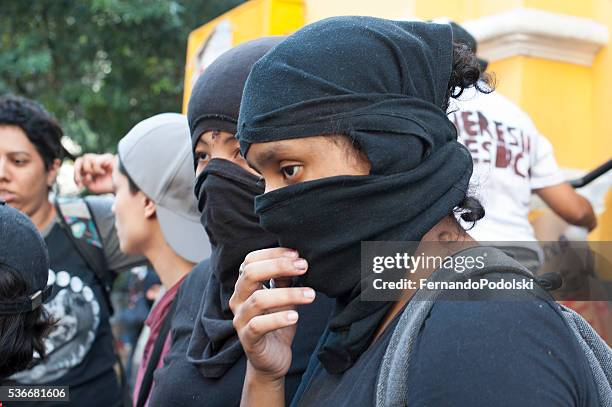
[255,145,471,373]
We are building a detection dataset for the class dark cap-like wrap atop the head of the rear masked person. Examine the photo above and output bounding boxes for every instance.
[187,37,285,156]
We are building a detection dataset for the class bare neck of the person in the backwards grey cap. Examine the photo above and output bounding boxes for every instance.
[143,230,194,289]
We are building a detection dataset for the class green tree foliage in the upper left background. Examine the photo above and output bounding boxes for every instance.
[0,0,242,152]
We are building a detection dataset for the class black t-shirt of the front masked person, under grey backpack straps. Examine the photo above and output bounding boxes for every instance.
[294,300,598,407]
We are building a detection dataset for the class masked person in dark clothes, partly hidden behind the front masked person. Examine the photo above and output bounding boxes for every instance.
[149,37,331,407]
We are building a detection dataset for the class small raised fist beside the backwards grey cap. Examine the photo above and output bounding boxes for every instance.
[74,154,115,194]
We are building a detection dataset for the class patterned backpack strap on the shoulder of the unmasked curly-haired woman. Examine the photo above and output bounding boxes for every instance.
[55,198,115,316]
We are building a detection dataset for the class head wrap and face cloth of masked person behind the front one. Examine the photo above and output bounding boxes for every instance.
[187,37,283,378]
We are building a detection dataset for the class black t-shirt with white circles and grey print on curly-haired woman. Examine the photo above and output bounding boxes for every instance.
[2,197,144,407]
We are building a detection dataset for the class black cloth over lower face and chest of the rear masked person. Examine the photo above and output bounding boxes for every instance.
[187,158,278,377]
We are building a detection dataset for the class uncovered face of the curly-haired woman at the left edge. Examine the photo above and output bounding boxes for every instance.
[0,126,55,216]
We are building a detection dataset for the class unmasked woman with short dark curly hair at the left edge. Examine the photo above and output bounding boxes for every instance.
[0,95,144,407]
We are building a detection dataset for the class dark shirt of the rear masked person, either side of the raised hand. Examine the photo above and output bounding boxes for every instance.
[149,262,332,407]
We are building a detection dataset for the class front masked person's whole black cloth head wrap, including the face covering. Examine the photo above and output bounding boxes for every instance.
[237,17,472,373]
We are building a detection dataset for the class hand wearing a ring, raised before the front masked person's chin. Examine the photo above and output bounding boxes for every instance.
[229,247,315,389]
